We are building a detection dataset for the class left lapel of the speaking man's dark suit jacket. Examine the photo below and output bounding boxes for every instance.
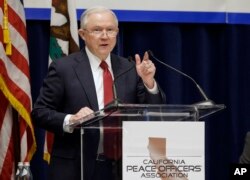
[75,51,99,111]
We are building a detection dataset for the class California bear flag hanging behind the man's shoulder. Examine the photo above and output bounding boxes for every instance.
[43,0,79,163]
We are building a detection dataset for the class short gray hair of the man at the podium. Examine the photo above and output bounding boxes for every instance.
[80,6,118,29]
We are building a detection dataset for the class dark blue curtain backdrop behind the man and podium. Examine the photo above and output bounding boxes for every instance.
[27,20,250,180]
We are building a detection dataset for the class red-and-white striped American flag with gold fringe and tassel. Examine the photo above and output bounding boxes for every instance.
[0,0,36,179]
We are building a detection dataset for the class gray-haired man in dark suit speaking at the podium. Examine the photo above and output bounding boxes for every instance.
[32,7,165,180]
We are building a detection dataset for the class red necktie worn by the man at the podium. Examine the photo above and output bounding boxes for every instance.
[100,61,122,159]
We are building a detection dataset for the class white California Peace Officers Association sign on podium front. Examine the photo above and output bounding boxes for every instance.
[123,121,205,180]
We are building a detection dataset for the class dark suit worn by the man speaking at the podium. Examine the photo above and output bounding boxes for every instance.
[32,49,165,180]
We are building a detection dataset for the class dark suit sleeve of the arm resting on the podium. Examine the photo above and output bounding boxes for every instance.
[32,62,66,133]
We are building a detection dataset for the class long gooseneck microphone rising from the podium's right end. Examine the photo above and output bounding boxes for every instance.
[147,50,214,106]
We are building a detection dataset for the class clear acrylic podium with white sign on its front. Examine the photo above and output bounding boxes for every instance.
[70,104,225,180]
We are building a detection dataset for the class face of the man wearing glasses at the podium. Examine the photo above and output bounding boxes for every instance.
[79,12,118,60]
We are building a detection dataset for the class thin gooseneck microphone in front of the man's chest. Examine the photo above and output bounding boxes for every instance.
[104,56,135,111]
